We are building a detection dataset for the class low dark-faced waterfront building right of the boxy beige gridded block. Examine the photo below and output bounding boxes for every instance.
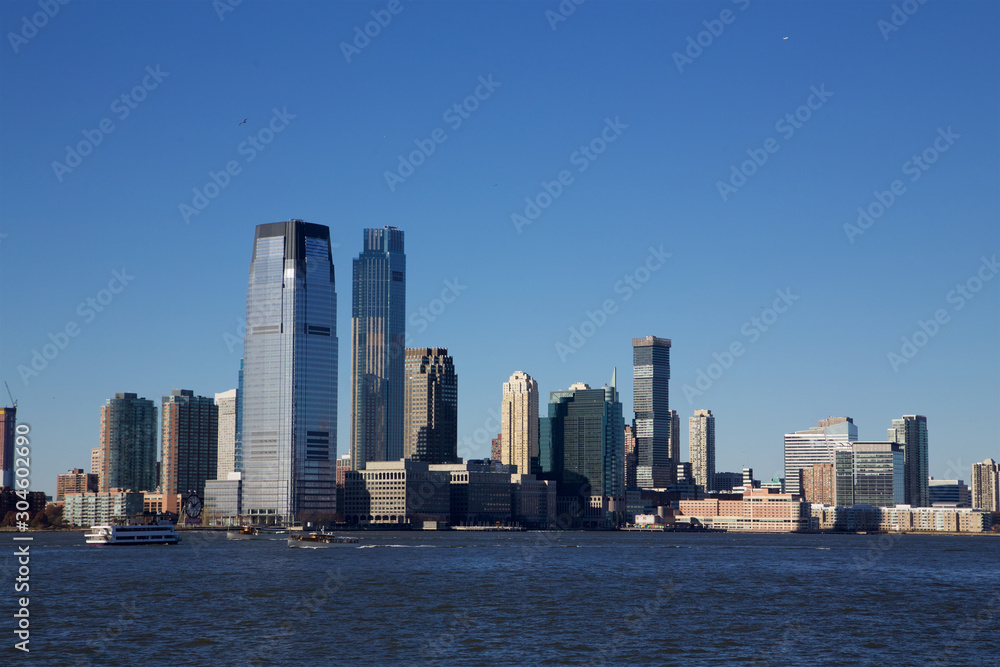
[428,461,512,526]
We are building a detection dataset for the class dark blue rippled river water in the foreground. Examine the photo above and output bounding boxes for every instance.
[0,533,1000,665]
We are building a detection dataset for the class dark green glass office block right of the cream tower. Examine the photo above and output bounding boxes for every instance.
[539,380,625,498]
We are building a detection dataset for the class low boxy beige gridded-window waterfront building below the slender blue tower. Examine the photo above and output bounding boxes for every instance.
[344,459,451,527]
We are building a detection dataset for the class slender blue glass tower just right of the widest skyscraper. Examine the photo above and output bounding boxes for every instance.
[351,227,406,470]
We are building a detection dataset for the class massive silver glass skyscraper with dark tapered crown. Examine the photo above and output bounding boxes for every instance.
[238,220,337,524]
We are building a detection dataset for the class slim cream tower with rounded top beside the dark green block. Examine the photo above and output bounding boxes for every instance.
[500,371,538,475]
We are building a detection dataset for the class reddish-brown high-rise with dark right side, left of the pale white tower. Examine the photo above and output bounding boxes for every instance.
[160,389,219,499]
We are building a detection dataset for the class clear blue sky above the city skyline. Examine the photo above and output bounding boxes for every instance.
[0,0,1000,493]
